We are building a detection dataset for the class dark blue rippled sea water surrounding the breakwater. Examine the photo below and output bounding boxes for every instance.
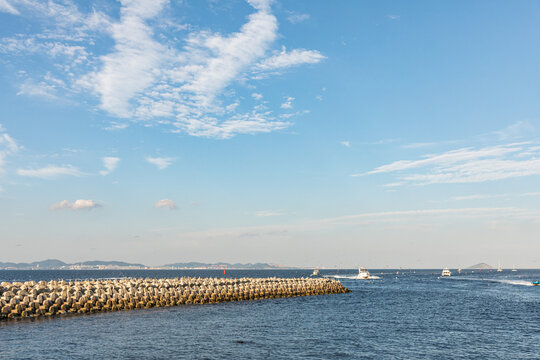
[0,270,540,359]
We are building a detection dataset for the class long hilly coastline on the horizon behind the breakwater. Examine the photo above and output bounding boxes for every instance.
[0,259,292,270]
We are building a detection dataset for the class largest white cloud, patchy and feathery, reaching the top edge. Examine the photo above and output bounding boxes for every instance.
[0,0,325,139]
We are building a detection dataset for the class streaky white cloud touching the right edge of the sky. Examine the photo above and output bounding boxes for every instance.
[358,142,540,185]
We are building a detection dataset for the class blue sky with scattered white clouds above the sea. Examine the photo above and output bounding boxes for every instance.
[0,0,540,267]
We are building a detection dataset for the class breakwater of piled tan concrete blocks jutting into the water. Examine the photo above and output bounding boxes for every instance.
[0,277,349,319]
